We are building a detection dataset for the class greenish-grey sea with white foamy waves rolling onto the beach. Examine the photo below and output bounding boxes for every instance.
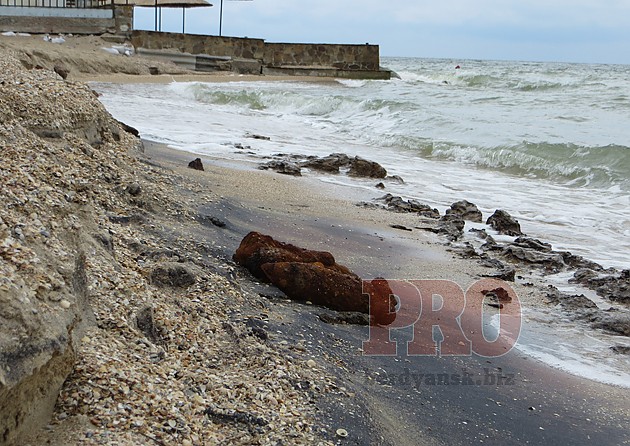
[95,58,630,386]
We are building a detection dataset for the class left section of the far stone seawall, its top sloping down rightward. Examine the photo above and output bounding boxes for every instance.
[131,31,265,60]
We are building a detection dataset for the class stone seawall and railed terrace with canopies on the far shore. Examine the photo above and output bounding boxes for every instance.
[0,0,391,79]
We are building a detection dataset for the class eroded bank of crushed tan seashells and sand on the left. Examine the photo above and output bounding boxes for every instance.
[0,51,328,444]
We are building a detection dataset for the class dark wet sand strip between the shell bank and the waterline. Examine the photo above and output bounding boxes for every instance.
[145,143,630,445]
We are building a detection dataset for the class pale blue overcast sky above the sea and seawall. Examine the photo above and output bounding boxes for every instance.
[135,0,630,64]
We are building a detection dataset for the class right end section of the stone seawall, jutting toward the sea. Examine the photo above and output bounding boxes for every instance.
[264,43,379,71]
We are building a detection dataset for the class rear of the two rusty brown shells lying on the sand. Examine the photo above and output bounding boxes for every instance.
[233,232,340,282]
